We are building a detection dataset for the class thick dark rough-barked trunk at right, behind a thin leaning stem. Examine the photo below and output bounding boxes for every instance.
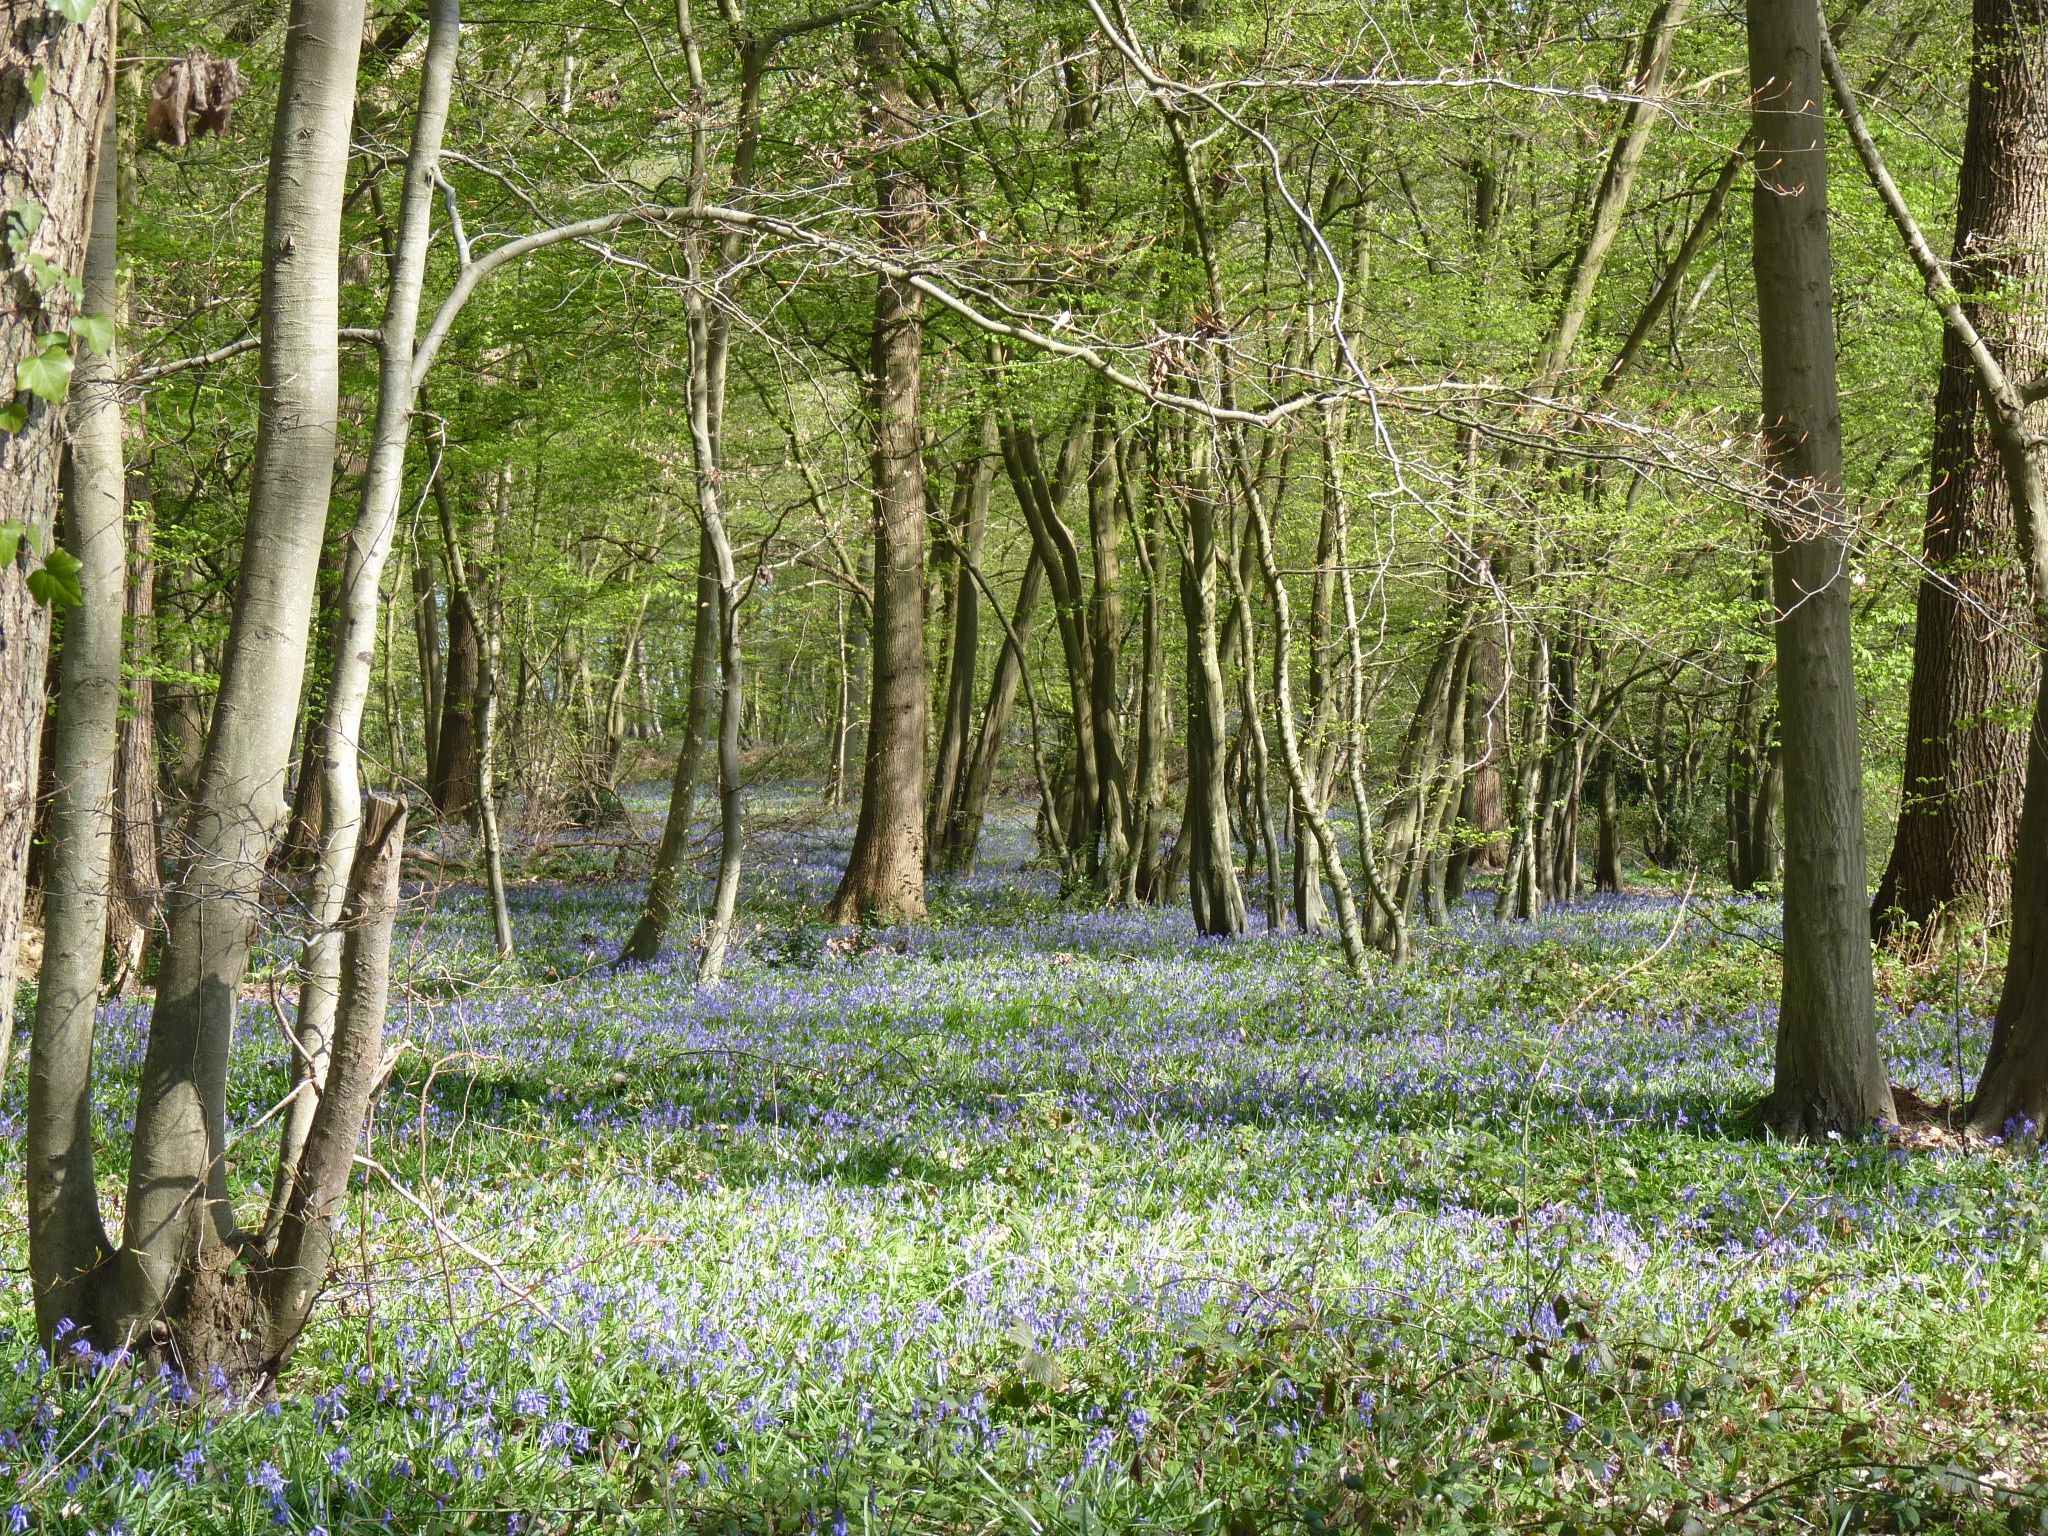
[1870,0,2048,952]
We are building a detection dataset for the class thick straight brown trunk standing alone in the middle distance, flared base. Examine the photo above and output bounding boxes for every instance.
[825,23,930,924]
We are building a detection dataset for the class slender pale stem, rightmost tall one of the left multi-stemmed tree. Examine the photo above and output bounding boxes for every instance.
[264,0,463,1231]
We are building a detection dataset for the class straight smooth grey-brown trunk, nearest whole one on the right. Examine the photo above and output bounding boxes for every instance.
[1749,0,1892,1137]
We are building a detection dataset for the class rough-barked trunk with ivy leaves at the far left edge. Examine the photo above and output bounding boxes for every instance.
[0,0,115,1081]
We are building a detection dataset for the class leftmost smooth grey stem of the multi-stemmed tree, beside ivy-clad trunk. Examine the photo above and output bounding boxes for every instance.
[25,123,127,1350]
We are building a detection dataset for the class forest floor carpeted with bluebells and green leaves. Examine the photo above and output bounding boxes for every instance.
[0,798,2048,1536]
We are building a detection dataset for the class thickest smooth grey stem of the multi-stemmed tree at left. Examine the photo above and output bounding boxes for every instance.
[102,0,362,1348]
